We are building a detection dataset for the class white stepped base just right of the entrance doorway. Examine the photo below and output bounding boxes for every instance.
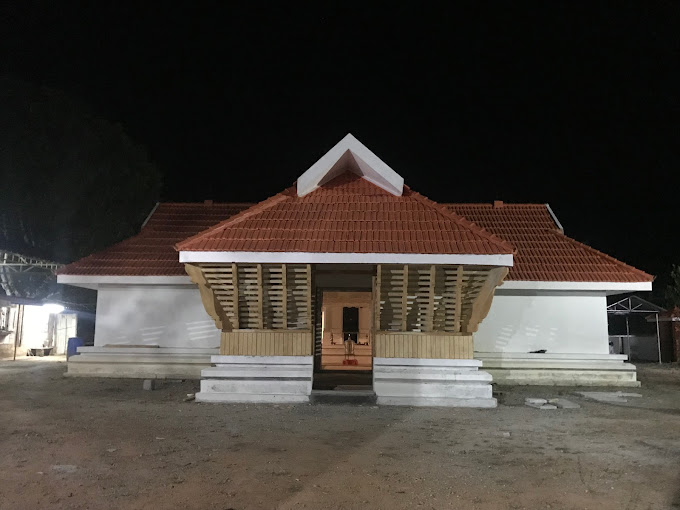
[373,358,496,407]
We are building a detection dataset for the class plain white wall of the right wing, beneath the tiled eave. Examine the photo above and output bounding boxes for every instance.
[474,290,609,354]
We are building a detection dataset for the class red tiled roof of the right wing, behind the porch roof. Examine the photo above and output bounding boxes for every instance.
[447,204,654,282]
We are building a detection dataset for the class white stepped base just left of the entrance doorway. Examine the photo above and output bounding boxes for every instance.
[196,356,314,403]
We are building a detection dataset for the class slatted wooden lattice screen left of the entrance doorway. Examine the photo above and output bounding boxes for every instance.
[187,264,312,330]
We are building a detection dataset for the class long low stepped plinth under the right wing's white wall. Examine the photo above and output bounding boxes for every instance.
[475,352,640,387]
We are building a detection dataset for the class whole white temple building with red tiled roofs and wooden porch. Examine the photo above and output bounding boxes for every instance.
[58,135,653,407]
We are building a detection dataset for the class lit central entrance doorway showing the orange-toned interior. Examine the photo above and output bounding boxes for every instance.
[320,291,373,372]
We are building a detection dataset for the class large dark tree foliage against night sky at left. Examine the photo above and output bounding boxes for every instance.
[0,76,161,262]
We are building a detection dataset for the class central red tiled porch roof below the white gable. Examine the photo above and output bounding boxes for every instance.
[177,172,513,255]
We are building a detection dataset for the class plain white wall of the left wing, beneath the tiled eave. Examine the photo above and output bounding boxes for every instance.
[94,285,220,348]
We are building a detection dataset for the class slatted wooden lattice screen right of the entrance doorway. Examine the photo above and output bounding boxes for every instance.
[377,265,507,333]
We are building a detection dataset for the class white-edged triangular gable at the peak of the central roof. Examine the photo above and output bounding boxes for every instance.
[297,133,404,197]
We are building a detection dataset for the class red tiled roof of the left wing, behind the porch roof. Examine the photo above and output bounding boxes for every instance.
[58,203,252,276]
